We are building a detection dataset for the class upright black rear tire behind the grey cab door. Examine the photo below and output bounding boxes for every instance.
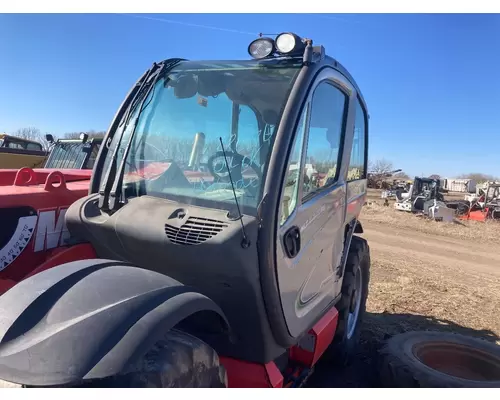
[328,236,370,366]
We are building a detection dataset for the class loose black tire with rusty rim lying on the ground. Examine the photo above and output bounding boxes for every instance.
[379,332,500,388]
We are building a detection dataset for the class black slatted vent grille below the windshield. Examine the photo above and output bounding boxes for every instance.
[165,217,228,246]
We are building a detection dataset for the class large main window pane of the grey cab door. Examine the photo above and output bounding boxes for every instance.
[303,82,347,199]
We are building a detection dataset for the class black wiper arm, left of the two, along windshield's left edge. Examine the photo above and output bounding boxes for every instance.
[99,63,157,210]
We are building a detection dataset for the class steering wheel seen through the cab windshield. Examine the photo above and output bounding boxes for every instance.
[207,151,262,186]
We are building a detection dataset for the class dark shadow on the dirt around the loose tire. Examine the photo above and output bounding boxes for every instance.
[307,312,500,388]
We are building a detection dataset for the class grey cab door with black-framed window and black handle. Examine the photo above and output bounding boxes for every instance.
[276,68,356,337]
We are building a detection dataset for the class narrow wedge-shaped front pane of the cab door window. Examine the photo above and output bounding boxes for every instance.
[280,107,308,225]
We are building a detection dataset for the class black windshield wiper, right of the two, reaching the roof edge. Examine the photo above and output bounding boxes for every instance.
[108,58,184,211]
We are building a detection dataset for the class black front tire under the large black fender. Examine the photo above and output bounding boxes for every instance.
[0,330,227,388]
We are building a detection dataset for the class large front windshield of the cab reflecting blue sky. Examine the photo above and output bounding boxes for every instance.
[102,61,300,211]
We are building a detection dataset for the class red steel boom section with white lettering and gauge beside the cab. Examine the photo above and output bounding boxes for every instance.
[0,168,92,294]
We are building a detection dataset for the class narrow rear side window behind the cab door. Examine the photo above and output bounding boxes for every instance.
[347,99,366,181]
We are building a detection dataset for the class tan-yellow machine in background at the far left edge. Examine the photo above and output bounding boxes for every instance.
[0,133,47,169]
